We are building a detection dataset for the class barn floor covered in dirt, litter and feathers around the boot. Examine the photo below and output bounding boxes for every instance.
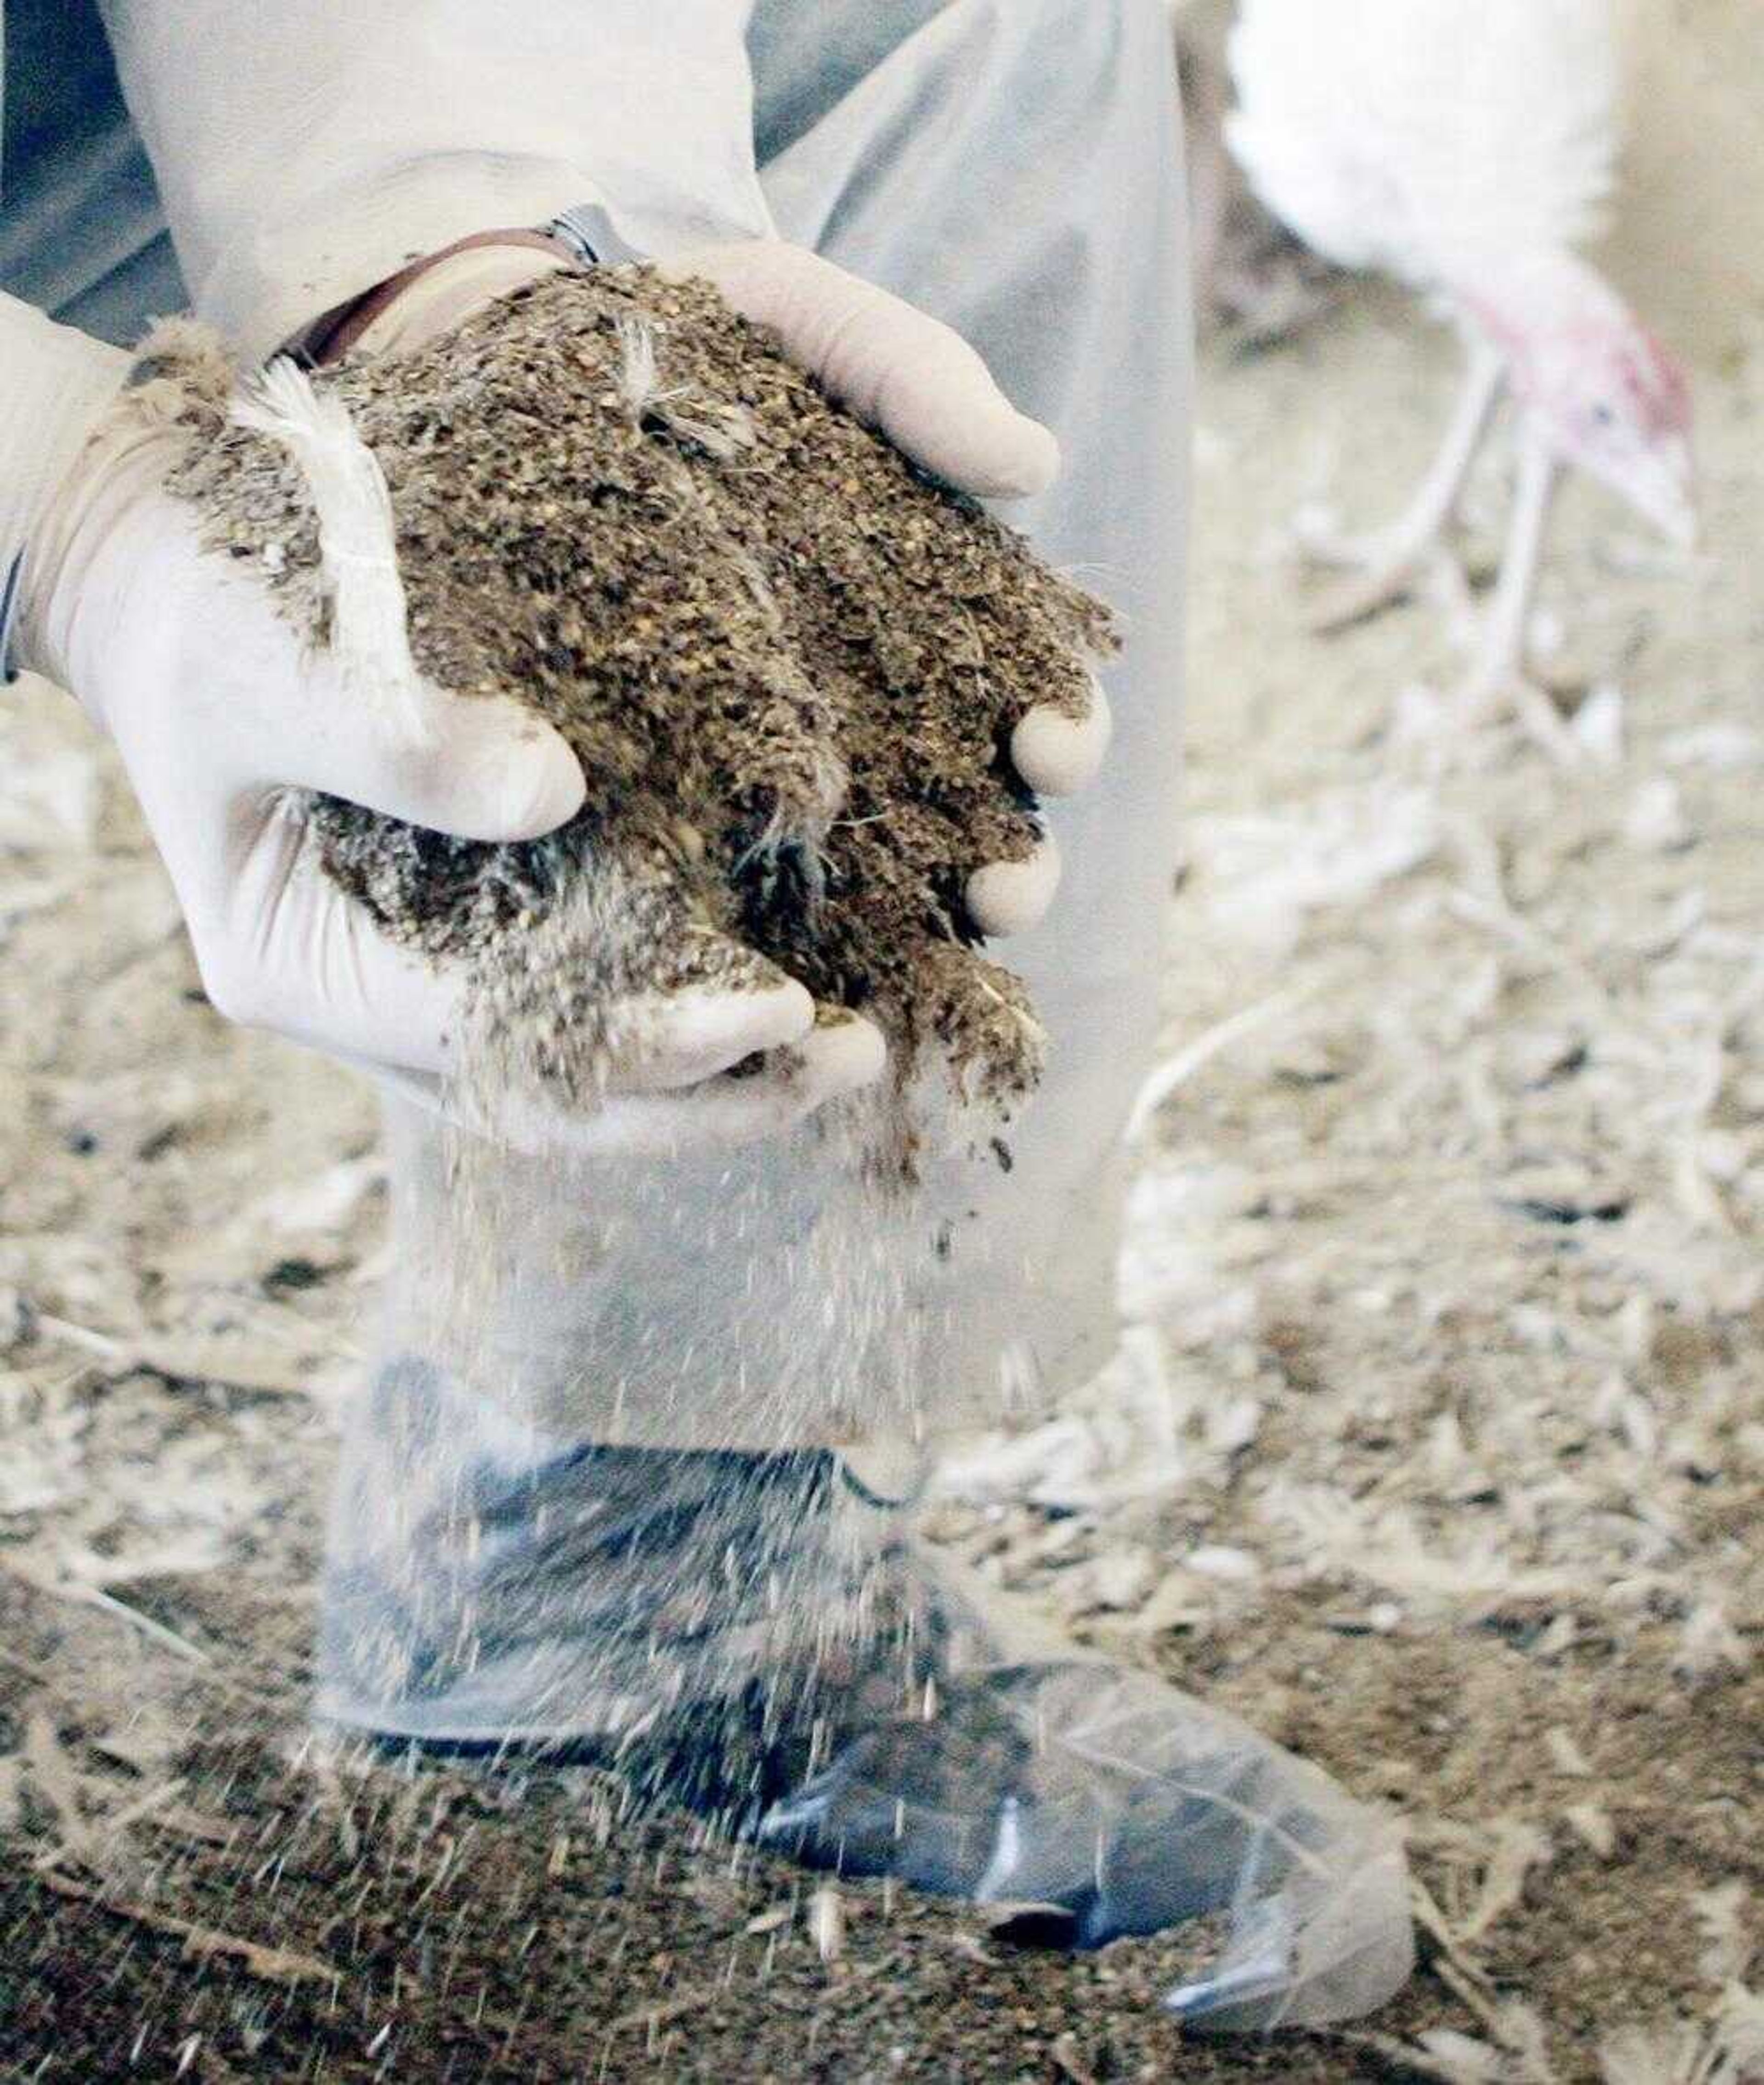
[0,285,1764,2085]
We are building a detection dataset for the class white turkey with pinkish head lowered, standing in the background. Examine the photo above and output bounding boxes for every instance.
[1228,0,1695,746]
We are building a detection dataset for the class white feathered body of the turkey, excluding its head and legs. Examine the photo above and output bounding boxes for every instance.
[1230,0,1622,288]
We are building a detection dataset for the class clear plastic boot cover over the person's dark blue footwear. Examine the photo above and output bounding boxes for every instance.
[319,1192,1409,2028]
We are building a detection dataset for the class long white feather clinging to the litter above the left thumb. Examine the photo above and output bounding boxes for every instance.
[233,356,430,740]
